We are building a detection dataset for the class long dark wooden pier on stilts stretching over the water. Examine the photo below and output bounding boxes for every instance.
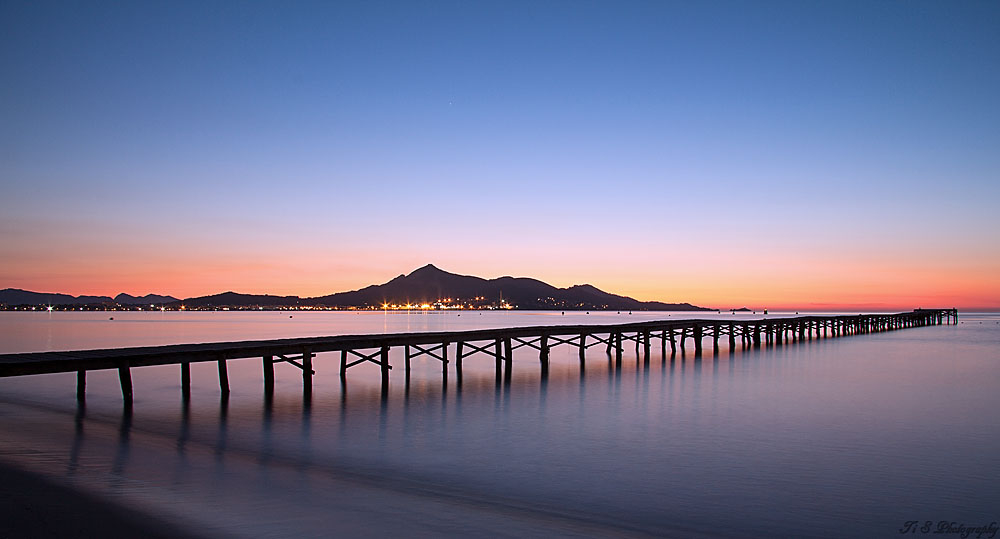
[0,309,958,408]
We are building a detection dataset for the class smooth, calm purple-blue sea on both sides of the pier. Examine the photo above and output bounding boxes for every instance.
[0,312,1000,537]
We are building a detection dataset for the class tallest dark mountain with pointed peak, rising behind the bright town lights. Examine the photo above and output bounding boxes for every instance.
[303,264,712,311]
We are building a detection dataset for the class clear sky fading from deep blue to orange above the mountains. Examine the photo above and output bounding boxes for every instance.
[0,0,1000,310]
